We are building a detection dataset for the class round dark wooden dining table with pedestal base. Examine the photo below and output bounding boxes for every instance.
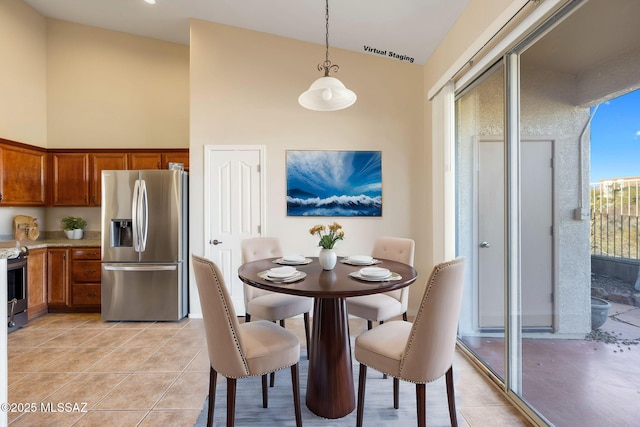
[238,258,417,419]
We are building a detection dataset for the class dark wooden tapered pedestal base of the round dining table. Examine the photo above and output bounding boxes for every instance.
[307,298,356,419]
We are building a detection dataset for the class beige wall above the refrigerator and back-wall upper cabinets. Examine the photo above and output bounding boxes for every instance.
[47,19,189,148]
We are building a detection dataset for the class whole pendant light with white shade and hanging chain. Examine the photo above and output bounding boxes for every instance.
[298,0,357,111]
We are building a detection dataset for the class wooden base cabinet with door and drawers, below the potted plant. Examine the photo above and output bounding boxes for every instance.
[47,247,101,313]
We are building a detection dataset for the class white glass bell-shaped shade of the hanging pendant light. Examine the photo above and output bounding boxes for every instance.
[298,76,357,111]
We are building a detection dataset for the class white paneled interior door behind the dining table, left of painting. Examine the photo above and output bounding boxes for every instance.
[204,146,264,315]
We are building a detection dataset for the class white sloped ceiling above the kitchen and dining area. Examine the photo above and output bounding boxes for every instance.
[24,0,470,64]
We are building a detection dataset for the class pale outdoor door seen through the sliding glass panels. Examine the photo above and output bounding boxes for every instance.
[477,140,554,330]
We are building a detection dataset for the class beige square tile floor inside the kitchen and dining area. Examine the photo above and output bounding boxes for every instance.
[7,314,529,427]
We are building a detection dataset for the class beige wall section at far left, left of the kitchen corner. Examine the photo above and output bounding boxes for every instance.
[0,0,47,147]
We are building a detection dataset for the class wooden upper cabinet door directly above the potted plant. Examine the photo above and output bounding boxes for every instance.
[49,152,90,206]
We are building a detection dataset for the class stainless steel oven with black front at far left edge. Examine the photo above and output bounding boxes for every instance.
[7,256,28,332]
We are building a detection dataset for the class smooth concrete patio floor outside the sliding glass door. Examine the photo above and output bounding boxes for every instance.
[465,303,640,427]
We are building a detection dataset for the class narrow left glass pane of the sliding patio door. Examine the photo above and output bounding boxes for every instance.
[455,61,506,380]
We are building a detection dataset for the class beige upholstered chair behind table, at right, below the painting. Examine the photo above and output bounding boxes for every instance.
[347,237,415,329]
